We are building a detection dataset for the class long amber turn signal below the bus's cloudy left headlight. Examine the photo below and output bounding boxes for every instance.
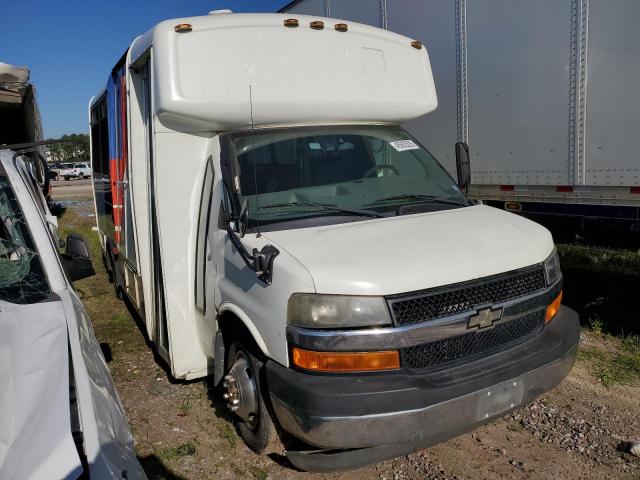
[292,347,400,372]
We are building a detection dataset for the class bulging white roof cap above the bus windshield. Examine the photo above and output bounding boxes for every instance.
[128,14,437,131]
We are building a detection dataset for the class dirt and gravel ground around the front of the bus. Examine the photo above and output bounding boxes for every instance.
[60,205,640,480]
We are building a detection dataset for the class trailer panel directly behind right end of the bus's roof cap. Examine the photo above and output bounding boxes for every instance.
[384,0,457,173]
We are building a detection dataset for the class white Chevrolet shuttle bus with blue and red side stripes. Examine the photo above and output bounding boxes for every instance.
[89,13,579,471]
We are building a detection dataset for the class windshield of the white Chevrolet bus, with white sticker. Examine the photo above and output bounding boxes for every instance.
[229,126,469,228]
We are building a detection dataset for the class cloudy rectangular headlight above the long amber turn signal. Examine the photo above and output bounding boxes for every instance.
[287,293,391,328]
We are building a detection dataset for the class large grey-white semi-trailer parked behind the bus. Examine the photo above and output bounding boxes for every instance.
[281,0,640,230]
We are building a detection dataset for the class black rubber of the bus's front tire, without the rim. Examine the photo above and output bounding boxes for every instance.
[226,340,278,454]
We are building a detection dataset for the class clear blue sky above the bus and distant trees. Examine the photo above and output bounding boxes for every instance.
[0,0,289,138]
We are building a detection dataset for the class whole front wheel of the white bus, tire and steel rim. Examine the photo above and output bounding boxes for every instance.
[222,341,278,453]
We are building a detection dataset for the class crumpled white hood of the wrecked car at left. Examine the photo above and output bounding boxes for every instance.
[0,301,82,479]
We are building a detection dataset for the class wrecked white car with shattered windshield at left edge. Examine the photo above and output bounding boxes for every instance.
[0,149,145,480]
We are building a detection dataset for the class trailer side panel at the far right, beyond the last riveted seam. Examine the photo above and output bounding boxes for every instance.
[585,0,640,186]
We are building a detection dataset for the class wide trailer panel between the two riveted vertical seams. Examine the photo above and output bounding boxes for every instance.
[467,0,572,185]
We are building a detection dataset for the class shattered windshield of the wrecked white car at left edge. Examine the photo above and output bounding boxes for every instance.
[0,168,49,304]
